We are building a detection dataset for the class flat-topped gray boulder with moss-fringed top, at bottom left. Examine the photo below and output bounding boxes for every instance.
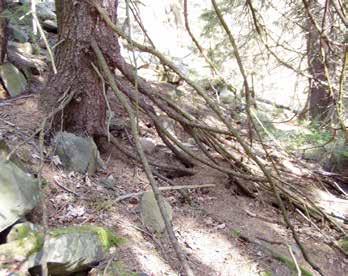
[29,226,120,276]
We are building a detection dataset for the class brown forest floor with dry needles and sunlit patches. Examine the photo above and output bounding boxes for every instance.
[0,91,348,276]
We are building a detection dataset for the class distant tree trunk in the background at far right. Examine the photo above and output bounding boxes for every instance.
[307,0,333,121]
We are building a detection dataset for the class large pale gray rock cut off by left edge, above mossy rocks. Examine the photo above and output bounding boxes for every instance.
[0,158,40,232]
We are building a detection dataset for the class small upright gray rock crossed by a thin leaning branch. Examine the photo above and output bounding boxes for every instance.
[140,192,173,233]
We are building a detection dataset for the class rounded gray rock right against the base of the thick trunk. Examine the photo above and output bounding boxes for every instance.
[54,132,100,175]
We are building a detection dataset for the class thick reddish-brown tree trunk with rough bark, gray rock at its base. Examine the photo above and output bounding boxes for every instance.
[41,0,121,136]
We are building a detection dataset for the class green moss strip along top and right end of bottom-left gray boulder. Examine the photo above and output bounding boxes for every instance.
[50,225,124,250]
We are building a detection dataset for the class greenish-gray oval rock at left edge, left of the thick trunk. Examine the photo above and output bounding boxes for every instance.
[0,63,27,97]
